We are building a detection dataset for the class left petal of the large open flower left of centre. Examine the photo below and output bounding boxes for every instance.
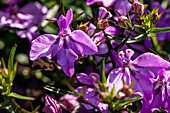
[30,34,58,60]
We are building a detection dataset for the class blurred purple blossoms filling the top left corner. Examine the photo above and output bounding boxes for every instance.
[0,0,48,41]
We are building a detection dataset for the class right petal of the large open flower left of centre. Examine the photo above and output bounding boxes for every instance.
[69,30,97,55]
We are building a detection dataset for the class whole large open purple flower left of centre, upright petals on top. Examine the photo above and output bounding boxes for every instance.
[30,9,97,76]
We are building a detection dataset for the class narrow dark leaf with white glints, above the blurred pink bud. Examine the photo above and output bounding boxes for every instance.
[44,85,71,95]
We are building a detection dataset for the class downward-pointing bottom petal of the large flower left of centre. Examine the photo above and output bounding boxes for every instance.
[57,42,78,77]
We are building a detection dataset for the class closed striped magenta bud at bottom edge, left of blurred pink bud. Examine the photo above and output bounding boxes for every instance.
[42,95,62,113]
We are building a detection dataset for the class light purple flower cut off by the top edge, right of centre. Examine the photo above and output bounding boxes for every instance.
[86,0,116,7]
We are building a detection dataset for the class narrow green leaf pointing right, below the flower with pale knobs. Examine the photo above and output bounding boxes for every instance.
[115,96,142,108]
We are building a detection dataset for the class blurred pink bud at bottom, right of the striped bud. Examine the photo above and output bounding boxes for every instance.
[59,95,79,111]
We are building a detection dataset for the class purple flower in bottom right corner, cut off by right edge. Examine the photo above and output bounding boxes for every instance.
[141,69,170,113]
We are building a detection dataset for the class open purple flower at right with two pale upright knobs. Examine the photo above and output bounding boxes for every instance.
[107,49,170,102]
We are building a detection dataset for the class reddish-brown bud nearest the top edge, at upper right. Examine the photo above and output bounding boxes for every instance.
[131,2,144,13]
